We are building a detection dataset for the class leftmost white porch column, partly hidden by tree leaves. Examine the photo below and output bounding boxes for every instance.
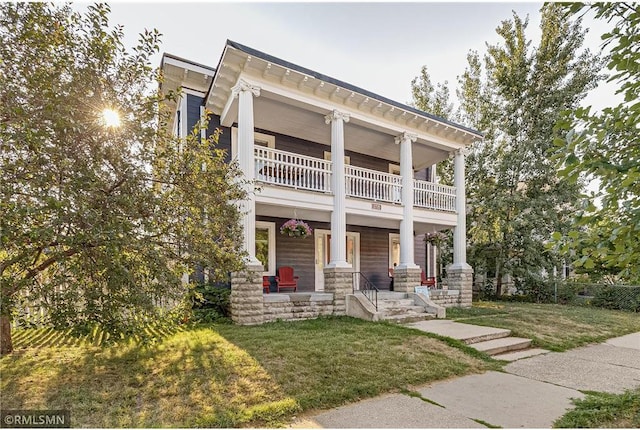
[231,79,261,264]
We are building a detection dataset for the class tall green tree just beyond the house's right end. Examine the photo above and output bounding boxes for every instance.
[414,4,600,294]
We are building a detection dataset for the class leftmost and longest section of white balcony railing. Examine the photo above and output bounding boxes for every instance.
[255,146,331,193]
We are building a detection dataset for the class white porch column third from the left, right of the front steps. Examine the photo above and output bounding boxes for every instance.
[395,132,418,269]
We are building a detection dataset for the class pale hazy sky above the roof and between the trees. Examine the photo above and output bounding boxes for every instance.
[87,2,613,111]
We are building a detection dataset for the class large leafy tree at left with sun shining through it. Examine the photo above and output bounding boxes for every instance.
[0,3,244,353]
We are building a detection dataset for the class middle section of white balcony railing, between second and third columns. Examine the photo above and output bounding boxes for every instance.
[345,166,402,203]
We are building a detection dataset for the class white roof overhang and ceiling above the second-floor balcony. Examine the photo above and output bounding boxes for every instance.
[206,41,482,169]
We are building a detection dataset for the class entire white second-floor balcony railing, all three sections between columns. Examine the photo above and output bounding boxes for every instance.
[255,146,456,212]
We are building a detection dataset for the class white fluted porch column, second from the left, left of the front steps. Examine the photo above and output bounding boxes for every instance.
[324,110,351,268]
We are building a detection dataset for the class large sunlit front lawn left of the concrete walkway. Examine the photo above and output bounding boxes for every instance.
[0,317,494,427]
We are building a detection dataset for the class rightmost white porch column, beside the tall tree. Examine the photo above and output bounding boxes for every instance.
[451,149,471,269]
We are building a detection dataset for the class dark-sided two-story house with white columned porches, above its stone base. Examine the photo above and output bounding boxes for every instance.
[161,41,482,322]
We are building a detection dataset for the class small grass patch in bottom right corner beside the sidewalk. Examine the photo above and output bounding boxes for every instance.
[553,388,640,428]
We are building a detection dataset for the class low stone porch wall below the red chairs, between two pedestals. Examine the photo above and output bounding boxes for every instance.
[263,293,334,322]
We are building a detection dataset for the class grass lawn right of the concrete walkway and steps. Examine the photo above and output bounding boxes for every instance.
[447,302,640,351]
